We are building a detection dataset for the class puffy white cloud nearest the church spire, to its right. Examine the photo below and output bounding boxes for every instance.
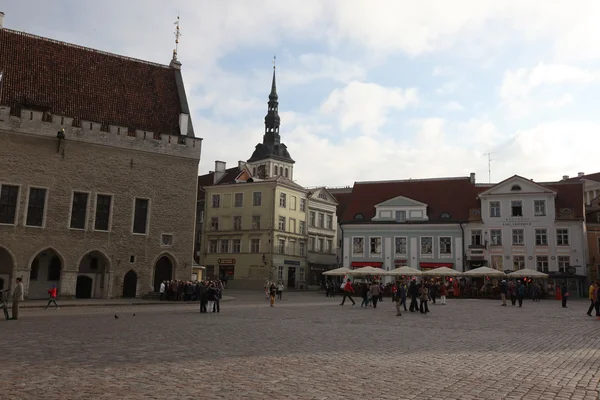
[321,81,419,135]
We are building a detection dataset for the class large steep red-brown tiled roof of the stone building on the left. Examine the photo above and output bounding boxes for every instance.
[0,29,187,135]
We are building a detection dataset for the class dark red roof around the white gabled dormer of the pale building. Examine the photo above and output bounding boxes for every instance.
[342,177,481,222]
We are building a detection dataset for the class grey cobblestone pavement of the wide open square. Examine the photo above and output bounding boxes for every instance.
[0,293,600,400]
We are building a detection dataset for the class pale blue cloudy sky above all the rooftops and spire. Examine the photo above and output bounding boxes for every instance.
[0,0,600,186]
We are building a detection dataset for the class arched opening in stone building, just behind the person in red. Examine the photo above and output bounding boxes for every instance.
[28,249,63,299]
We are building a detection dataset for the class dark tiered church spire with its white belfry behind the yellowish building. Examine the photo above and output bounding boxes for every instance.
[247,62,295,180]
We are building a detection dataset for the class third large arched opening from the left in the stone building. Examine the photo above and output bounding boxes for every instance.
[75,250,110,299]
